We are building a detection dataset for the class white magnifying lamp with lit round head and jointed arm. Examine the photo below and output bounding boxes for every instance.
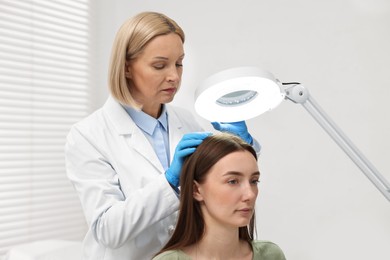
[195,67,390,201]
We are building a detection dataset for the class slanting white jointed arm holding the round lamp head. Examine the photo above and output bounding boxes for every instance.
[283,83,390,201]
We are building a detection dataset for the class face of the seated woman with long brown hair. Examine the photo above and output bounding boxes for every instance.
[194,151,260,228]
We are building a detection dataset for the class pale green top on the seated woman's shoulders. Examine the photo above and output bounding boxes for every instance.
[153,241,286,260]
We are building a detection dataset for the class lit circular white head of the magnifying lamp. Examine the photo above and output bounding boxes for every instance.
[195,67,285,122]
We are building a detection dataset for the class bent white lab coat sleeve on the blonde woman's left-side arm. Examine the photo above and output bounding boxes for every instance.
[65,127,179,248]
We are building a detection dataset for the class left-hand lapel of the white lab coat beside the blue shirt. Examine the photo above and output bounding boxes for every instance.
[104,97,164,173]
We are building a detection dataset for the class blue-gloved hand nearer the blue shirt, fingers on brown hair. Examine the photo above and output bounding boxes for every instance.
[165,132,211,187]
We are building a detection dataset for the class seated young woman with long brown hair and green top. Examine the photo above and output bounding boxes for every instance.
[153,133,285,260]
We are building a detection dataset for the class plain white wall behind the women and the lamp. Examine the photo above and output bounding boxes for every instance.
[96,0,390,260]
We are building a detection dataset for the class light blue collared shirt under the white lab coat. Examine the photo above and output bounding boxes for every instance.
[123,105,170,171]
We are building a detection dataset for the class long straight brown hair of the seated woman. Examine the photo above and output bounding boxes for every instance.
[158,133,257,254]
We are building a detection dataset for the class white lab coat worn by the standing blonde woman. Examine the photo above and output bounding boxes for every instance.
[65,97,202,260]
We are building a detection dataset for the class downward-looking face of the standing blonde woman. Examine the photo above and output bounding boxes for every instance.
[126,33,184,117]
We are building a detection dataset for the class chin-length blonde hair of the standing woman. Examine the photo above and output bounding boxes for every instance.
[108,12,185,108]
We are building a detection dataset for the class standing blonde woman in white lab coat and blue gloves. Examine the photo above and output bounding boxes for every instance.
[65,12,260,260]
